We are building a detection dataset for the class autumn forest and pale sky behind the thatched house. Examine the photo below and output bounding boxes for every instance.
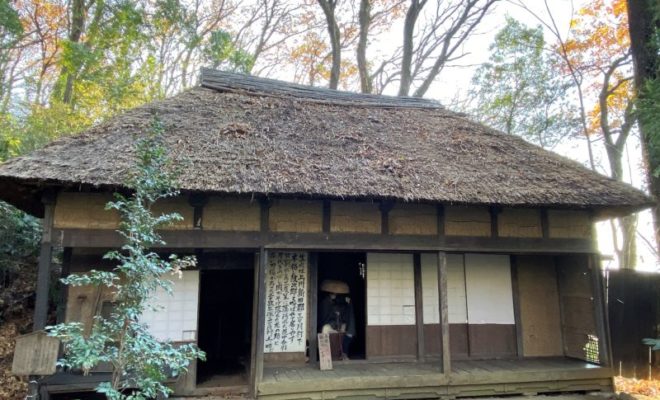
[0,0,660,274]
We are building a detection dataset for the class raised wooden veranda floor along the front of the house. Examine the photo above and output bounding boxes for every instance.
[259,358,612,399]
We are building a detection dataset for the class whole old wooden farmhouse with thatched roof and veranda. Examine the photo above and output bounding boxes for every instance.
[0,70,651,399]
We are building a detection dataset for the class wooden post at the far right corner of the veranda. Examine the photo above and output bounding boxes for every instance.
[589,254,612,367]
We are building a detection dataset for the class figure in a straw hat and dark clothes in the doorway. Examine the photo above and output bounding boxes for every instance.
[319,279,355,360]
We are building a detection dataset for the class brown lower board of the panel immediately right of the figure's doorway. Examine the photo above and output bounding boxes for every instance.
[367,325,417,358]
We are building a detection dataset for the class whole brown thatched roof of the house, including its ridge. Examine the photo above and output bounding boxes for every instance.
[0,71,651,219]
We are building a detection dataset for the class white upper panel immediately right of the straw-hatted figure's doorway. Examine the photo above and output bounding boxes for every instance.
[367,253,415,325]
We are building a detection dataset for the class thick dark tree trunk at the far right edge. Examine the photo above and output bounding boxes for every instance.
[627,0,660,249]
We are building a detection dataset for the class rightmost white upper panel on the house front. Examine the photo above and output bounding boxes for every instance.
[465,254,515,324]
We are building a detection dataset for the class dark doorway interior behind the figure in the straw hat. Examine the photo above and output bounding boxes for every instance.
[317,253,367,359]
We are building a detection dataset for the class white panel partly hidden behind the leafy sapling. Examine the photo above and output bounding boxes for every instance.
[140,271,199,342]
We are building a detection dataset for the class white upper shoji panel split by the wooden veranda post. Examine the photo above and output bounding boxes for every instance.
[422,253,467,324]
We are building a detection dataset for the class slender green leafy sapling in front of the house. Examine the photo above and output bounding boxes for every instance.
[47,118,205,400]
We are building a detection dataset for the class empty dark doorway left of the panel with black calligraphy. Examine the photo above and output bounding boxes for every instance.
[197,253,254,387]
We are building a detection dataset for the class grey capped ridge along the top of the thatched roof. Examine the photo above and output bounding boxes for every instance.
[200,68,444,109]
